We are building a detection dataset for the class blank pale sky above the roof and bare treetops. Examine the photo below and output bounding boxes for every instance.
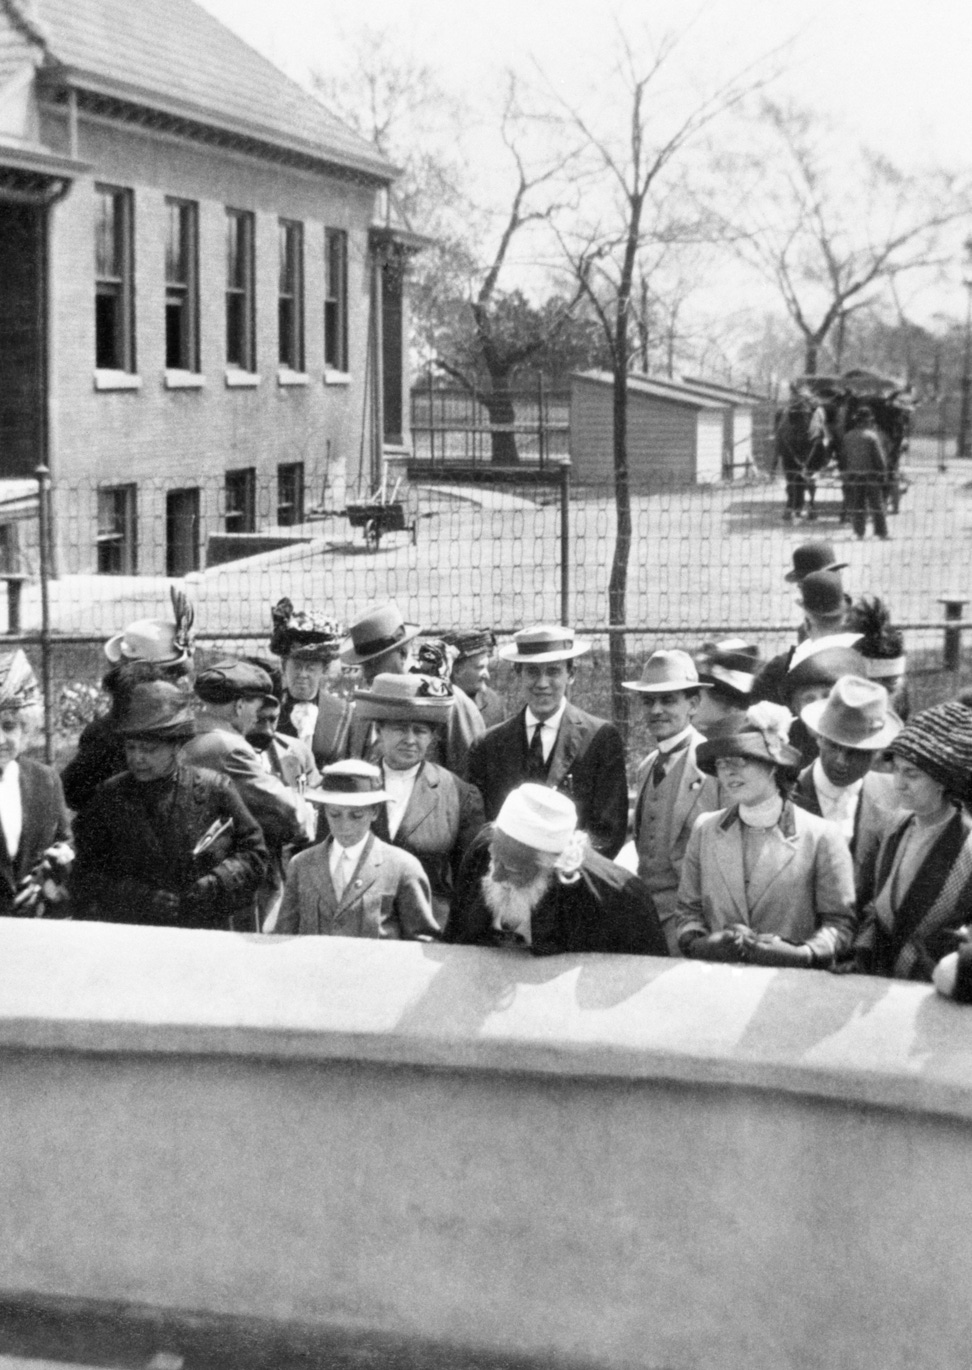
[202,0,972,342]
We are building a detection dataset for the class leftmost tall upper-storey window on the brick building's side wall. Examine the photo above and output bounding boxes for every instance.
[95,185,136,371]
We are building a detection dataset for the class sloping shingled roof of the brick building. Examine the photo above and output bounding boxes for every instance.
[0,0,395,181]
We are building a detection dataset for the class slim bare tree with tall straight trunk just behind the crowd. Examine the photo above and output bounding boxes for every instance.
[554,32,765,722]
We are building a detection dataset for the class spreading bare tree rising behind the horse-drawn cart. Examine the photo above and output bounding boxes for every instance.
[725,100,969,375]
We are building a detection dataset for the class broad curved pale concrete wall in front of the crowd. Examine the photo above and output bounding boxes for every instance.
[0,919,972,1370]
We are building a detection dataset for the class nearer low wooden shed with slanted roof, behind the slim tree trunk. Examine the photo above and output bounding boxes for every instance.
[570,371,731,485]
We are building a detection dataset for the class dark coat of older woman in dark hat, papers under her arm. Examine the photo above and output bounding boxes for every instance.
[71,766,267,930]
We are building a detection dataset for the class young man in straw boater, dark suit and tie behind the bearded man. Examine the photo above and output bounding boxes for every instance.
[465,625,628,856]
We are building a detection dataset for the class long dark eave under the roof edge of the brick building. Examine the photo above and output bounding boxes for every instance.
[37,67,399,188]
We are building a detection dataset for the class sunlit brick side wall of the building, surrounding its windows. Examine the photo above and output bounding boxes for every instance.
[44,111,374,574]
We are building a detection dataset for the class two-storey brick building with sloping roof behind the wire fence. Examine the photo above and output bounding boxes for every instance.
[0,0,415,575]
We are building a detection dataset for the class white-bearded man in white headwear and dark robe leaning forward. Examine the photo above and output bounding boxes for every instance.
[443,782,668,956]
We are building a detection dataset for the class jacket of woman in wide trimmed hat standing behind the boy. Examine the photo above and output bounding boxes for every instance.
[374,762,485,927]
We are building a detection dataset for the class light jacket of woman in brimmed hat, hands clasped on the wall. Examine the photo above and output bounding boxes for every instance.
[677,801,857,960]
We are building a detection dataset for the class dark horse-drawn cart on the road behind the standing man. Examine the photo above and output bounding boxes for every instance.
[773,371,914,523]
